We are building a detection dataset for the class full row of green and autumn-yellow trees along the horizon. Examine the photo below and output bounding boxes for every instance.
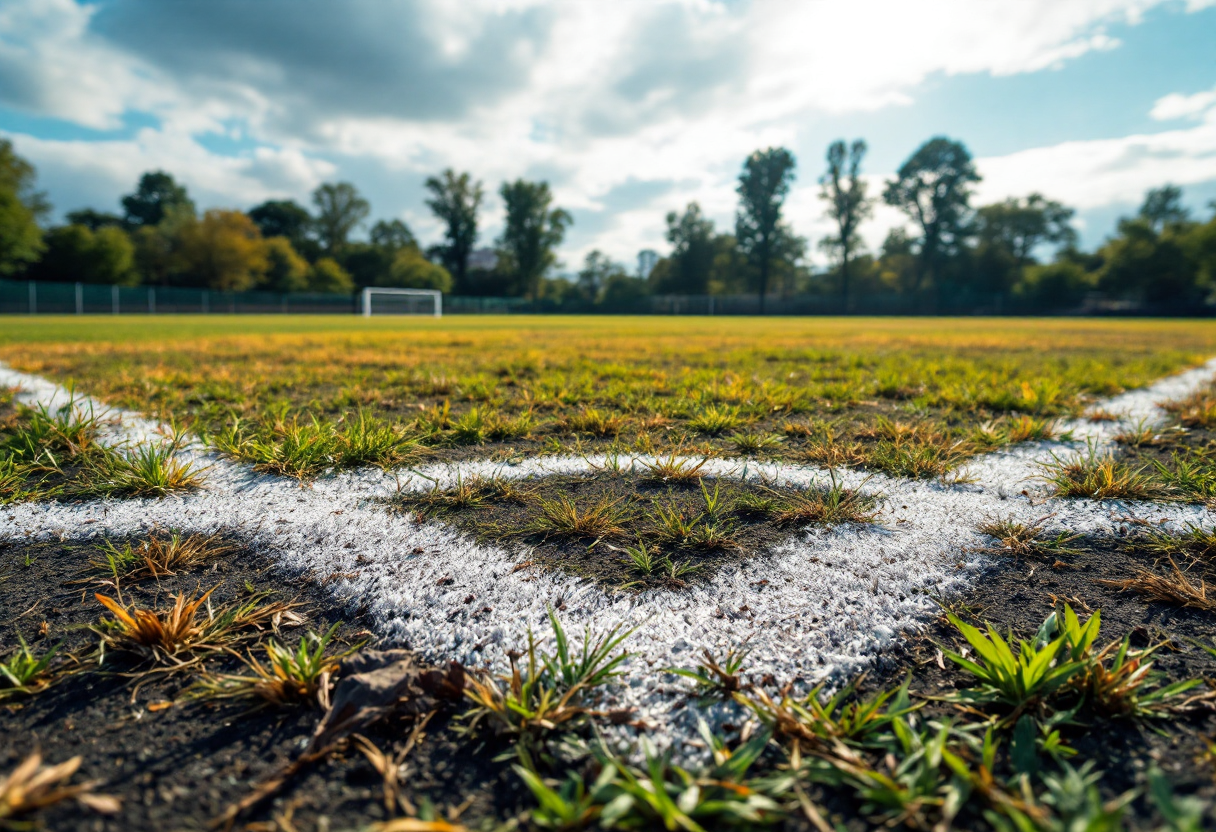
[0,136,1216,309]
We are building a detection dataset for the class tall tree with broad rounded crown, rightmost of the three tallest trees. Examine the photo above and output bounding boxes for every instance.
[883,136,980,291]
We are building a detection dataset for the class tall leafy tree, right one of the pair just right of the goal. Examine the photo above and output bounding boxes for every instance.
[499,179,574,300]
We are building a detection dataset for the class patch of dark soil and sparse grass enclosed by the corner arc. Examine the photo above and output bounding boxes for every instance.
[390,467,880,589]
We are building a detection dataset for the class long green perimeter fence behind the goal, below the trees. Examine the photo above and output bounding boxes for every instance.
[0,280,1214,317]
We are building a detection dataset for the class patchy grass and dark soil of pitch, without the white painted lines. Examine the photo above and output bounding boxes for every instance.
[7,317,1216,832]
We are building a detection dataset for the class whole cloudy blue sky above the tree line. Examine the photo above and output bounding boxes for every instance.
[0,0,1216,270]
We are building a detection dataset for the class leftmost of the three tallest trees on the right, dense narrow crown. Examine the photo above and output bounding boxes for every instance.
[734,147,794,314]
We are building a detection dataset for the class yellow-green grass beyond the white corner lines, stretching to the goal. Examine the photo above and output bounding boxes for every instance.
[0,316,1216,477]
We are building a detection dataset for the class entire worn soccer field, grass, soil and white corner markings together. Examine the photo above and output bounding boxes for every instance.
[0,316,1216,832]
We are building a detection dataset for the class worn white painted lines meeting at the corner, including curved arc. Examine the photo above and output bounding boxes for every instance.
[0,360,1216,740]
